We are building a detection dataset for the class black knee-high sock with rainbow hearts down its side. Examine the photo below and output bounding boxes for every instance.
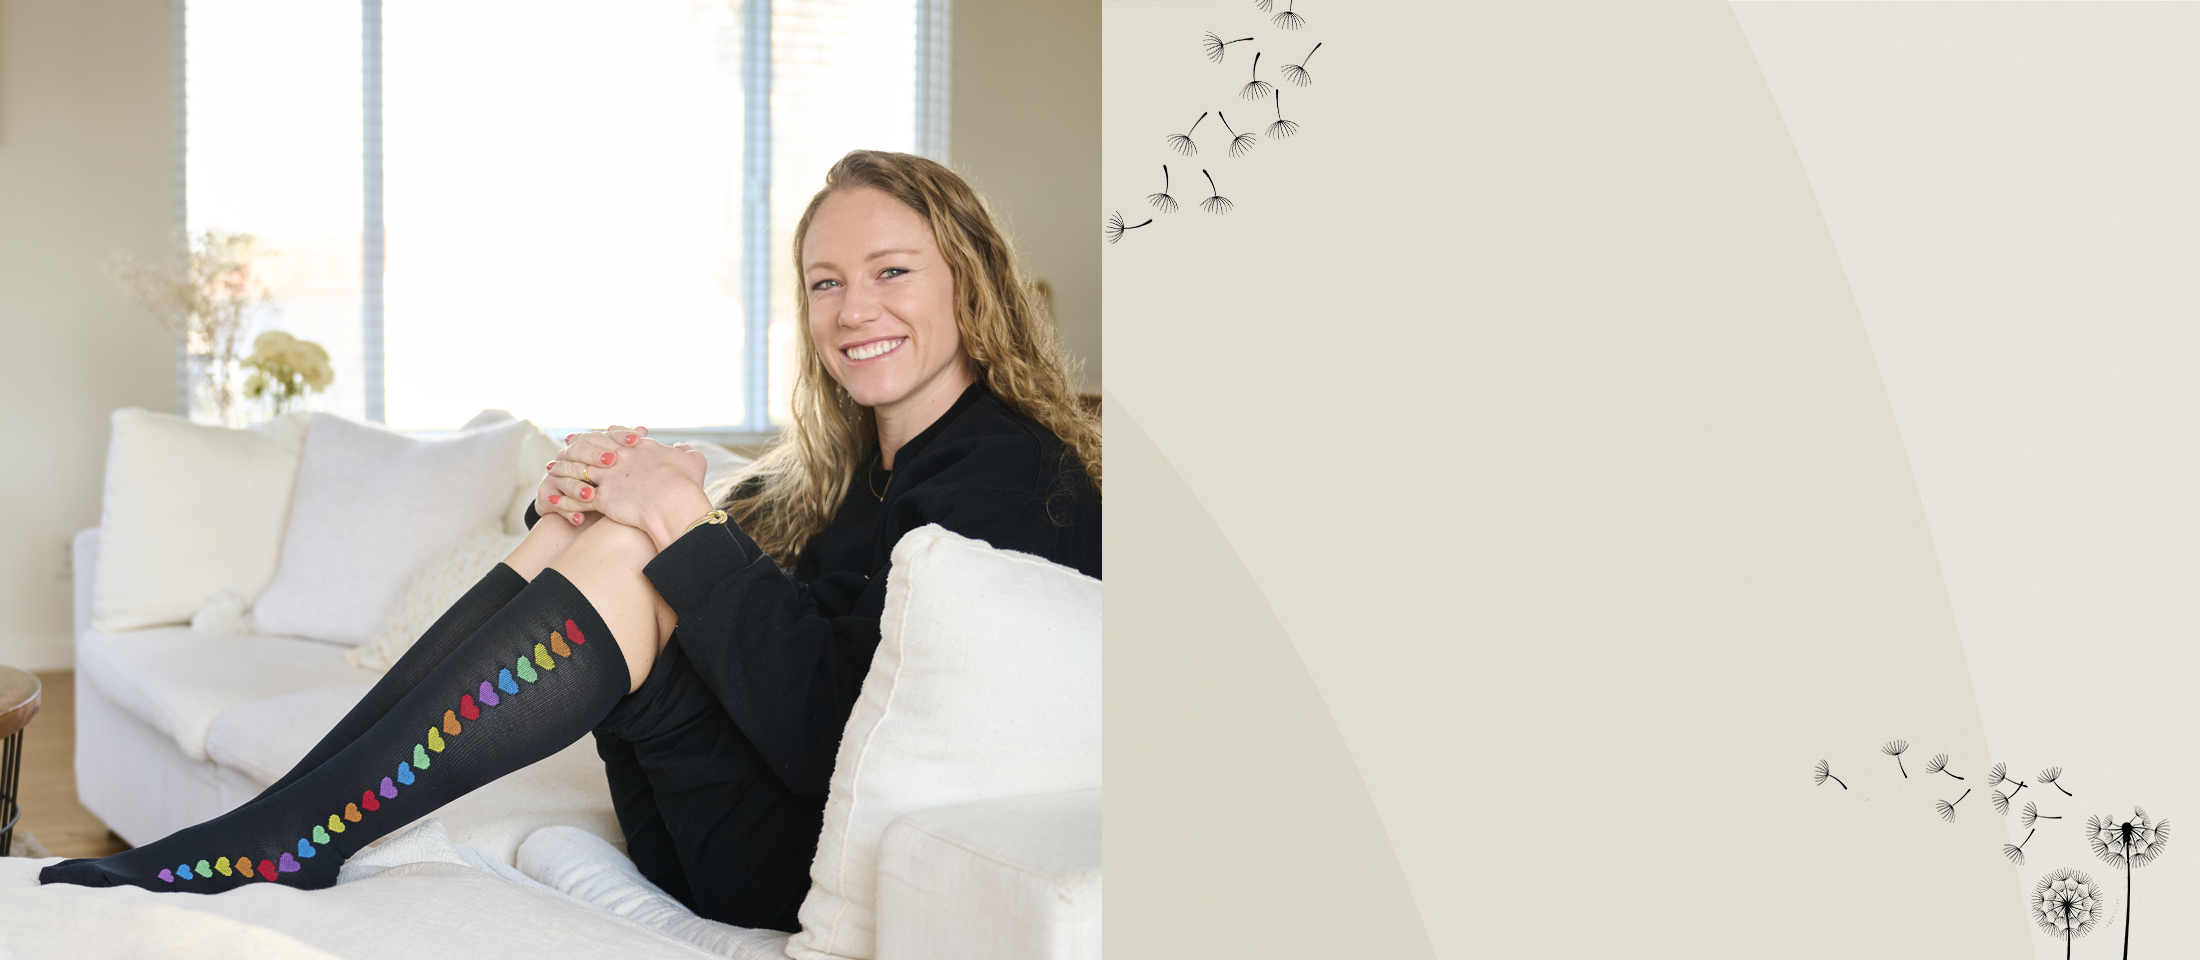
[37,570,629,894]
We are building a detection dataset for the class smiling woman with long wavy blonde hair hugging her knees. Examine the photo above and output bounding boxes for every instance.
[40,152,1100,931]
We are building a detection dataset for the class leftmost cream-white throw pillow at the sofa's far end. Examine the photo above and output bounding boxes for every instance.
[92,407,306,634]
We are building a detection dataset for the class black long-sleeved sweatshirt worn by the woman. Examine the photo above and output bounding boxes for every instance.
[530,385,1100,801]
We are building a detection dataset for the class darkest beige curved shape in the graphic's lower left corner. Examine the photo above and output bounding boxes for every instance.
[1104,399,1432,960]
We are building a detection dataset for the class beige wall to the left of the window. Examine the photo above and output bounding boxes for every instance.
[0,0,174,669]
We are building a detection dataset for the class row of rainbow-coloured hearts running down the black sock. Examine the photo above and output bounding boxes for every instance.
[154,621,587,883]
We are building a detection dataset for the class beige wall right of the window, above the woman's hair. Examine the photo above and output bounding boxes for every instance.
[948,0,1100,390]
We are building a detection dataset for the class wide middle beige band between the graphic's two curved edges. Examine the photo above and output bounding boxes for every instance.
[1102,2,2026,958]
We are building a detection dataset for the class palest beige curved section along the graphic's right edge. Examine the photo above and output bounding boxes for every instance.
[1736,4,2200,958]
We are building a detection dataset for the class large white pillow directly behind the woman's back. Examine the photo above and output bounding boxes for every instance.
[788,524,1100,960]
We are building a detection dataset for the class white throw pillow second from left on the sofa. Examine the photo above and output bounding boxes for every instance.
[253,414,535,643]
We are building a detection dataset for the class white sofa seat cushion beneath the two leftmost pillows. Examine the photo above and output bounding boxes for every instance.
[77,628,378,760]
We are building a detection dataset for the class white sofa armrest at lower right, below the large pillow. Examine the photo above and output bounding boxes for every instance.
[878,790,1100,960]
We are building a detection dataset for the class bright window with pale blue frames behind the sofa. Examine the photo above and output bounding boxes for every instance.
[185,0,946,432]
